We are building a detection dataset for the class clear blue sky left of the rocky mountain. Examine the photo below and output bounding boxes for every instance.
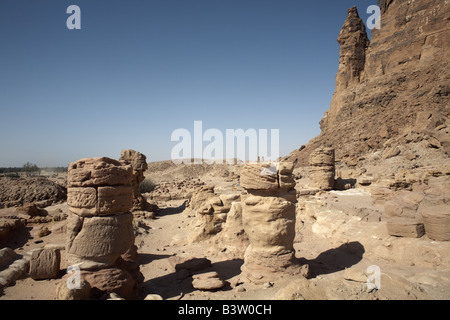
[0,0,377,167]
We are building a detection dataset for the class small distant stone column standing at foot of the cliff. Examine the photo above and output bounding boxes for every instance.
[309,147,335,190]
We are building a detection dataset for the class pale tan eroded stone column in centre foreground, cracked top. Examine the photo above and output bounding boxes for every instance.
[241,163,300,282]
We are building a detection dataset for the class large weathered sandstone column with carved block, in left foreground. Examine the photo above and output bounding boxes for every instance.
[62,157,138,298]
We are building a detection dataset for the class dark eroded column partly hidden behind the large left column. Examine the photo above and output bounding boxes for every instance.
[119,150,149,211]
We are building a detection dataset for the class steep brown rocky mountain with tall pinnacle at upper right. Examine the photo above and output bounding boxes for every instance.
[288,0,450,167]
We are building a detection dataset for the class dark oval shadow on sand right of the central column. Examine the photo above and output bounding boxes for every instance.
[298,241,365,278]
